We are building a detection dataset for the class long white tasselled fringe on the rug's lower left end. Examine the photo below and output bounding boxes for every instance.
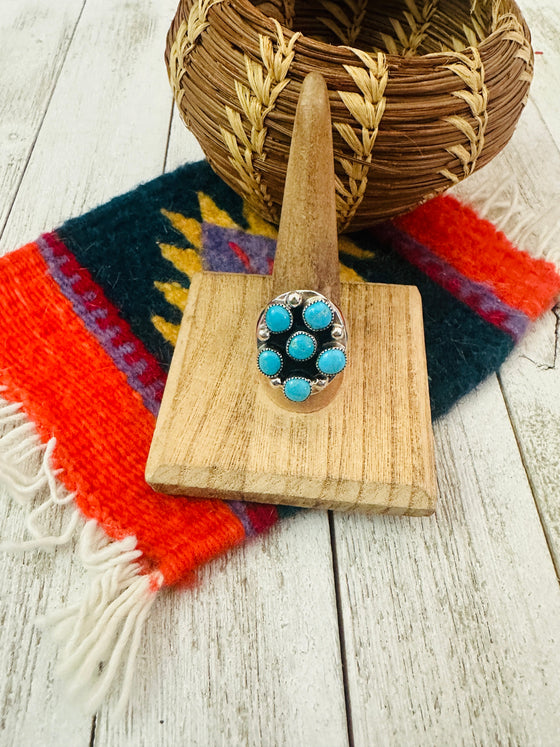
[0,387,163,713]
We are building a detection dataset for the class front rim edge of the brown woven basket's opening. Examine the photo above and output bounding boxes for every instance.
[217,0,526,66]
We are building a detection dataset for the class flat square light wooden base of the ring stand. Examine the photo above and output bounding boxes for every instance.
[146,273,436,516]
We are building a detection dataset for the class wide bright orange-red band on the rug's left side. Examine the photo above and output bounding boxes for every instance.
[0,244,245,585]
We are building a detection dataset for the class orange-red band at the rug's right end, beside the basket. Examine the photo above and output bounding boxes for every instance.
[393,195,560,320]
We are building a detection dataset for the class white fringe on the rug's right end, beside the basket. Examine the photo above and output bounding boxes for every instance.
[451,178,560,270]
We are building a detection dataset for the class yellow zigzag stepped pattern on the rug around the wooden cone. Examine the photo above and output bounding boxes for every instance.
[152,192,374,346]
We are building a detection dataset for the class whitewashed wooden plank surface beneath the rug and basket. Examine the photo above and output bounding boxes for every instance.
[0,0,560,747]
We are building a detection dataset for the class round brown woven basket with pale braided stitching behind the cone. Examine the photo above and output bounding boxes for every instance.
[166,0,533,231]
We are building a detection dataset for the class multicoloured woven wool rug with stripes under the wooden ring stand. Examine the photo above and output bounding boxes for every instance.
[0,162,560,709]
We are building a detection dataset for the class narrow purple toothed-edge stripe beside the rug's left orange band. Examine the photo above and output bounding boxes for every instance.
[37,236,165,415]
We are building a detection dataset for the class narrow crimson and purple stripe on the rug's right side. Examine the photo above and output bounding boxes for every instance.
[371,222,529,340]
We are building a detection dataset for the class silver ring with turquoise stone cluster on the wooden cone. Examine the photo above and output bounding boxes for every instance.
[257,290,348,402]
